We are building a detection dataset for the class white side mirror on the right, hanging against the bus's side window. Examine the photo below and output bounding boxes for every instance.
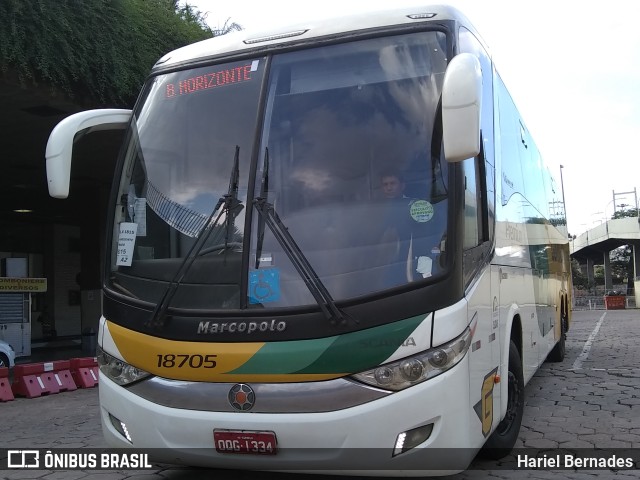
[442,53,482,162]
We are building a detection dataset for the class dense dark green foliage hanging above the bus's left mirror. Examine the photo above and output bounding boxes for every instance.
[0,0,230,108]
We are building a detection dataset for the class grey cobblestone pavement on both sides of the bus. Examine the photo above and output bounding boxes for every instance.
[0,310,640,480]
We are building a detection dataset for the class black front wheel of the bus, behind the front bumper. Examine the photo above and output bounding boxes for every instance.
[481,341,524,459]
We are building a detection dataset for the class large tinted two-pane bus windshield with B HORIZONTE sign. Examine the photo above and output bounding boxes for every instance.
[108,31,449,309]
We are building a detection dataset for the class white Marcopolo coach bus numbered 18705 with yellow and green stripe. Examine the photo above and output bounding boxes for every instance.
[46,6,571,475]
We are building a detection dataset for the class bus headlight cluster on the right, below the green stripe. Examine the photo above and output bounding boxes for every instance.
[351,328,472,390]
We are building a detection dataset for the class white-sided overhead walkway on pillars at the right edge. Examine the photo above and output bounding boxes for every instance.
[570,217,640,305]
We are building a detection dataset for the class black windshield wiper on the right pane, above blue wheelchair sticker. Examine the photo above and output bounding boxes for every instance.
[253,151,358,325]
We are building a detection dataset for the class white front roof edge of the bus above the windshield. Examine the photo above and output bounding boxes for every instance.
[153,5,477,71]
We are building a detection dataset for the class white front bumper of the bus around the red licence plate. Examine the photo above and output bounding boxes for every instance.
[100,359,480,476]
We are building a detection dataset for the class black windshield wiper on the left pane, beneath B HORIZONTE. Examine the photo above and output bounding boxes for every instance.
[144,149,244,327]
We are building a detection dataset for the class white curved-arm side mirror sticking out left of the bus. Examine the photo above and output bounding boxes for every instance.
[45,109,131,198]
